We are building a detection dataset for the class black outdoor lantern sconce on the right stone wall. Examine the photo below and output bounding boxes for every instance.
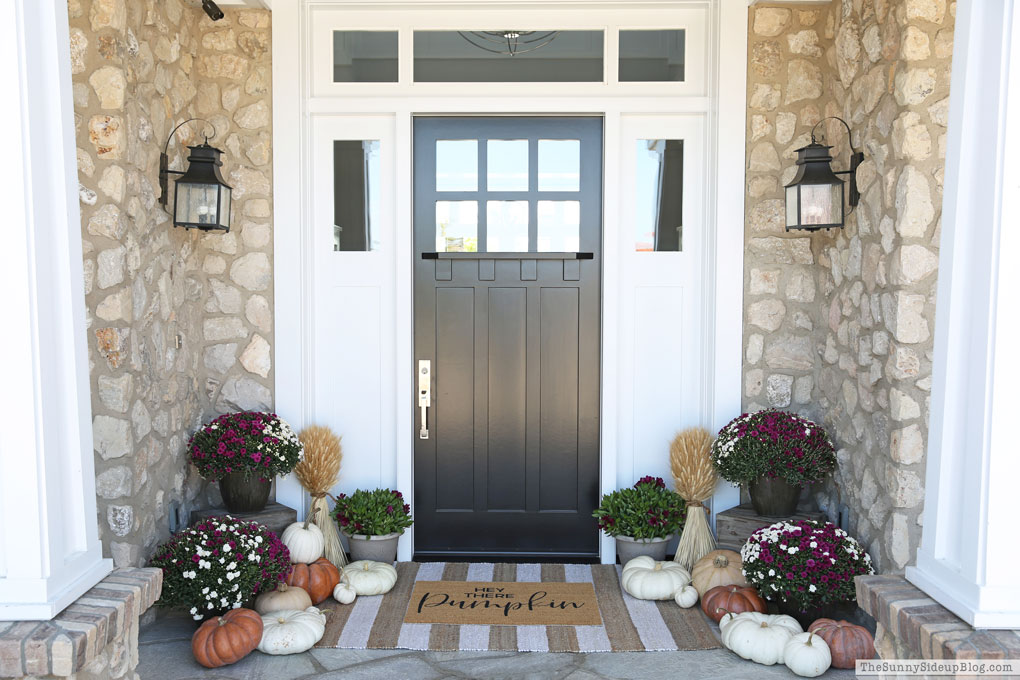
[786,116,864,231]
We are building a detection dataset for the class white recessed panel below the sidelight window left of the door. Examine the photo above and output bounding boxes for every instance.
[314,285,383,493]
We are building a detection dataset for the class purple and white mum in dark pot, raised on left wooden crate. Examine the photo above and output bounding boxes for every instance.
[188,411,304,513]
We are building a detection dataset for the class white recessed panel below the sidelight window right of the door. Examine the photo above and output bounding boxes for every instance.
[621,285,700,487]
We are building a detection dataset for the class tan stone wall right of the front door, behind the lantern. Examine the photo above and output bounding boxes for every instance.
[744,0,955,571]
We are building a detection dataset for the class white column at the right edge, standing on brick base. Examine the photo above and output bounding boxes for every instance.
[907,1,1020,628]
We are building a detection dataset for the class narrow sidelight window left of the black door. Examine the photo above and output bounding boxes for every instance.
[333,140,379,251]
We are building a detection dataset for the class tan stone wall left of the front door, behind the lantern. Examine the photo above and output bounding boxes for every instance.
[68,0,273,566]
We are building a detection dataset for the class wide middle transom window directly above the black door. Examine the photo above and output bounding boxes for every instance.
[414,30,603,83]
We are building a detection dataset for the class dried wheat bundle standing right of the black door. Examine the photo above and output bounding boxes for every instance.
[669,427,716,570]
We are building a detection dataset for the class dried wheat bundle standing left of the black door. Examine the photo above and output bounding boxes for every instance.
[294,425,347,569]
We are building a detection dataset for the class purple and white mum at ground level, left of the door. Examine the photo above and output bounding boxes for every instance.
[149,515,291,621]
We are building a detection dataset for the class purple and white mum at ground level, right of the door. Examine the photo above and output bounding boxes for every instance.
[741,520,874,628]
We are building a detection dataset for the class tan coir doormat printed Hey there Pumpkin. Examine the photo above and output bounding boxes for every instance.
[404,581,602,626]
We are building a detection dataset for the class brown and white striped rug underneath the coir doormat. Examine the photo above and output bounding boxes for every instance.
[316,562,719,651]
